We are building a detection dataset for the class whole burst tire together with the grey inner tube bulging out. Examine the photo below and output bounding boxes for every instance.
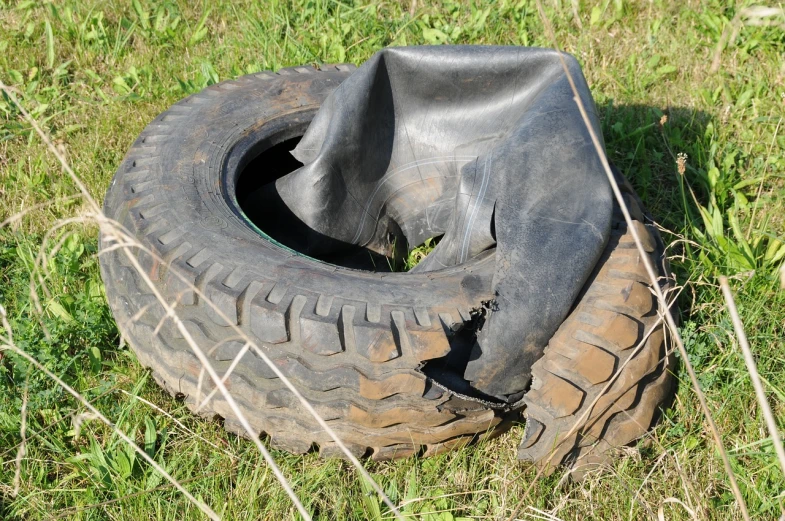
[101,48,669,463]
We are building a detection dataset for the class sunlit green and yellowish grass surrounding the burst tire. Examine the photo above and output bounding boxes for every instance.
[0,0,785,521]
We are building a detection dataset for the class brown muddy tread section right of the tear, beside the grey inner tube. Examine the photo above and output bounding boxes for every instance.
[518,173,674,477]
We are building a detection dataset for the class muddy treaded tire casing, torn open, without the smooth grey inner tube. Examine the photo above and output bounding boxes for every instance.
[100,65,664,459]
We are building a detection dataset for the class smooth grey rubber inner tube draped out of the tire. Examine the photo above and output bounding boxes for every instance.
[258,46,612,400]
